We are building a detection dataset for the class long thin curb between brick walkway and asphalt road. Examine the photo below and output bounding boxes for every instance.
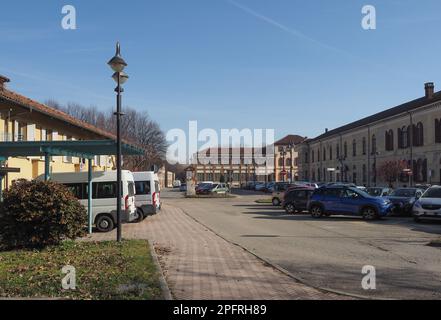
[178,208,384,300]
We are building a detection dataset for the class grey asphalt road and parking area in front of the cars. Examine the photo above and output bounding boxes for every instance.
[163,191,441,299]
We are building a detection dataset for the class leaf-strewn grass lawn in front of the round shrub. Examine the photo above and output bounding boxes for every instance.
[0,240,163,300]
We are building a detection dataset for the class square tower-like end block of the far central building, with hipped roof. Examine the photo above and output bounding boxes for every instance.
[272,135,306,182]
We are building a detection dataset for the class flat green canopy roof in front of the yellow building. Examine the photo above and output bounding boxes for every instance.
[0,140,144,159]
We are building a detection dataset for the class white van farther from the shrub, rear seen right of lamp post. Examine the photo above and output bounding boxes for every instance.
[133,171,161,218]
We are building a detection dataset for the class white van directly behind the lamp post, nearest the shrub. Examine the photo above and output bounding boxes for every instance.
[37,170,140,232]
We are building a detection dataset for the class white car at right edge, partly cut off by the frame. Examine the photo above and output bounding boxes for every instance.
[412,186,441,222]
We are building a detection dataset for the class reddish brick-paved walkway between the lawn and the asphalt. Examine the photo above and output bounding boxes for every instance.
[86,206,343,300]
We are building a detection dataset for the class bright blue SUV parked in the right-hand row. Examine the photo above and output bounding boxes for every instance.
[308,186,393,220]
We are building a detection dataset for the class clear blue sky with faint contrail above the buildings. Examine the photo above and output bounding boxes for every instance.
[0,0,441,141]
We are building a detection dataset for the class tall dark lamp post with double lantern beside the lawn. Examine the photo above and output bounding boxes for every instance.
[108,42,129,242]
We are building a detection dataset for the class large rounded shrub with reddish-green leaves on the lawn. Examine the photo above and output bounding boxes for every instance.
[0,180,87,249]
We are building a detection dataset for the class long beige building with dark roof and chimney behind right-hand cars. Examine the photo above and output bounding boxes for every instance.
[296,83,441,186]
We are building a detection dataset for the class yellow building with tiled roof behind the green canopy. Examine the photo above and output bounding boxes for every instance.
[0,76,115,190]
